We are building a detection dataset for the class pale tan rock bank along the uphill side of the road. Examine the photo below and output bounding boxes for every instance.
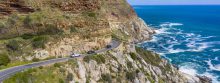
[33,37,111,59]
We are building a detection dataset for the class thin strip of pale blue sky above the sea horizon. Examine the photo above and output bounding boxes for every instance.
[127,0,220,5]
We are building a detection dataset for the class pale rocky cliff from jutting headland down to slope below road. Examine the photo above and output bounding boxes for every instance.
[47,15,207,83]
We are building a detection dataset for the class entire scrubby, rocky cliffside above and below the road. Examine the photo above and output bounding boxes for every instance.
[0,0,196,83]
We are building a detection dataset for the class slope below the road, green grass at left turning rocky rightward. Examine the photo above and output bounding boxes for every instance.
[4,47,180,83]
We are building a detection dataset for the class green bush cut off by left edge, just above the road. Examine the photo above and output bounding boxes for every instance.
[0,54,11,66]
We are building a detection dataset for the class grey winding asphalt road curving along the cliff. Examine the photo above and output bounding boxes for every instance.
[0,40,120,83]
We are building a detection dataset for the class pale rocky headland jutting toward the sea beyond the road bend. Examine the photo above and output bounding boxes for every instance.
[110,18,155,43]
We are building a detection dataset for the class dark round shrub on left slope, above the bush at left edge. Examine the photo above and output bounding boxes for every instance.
[6,40,20,51]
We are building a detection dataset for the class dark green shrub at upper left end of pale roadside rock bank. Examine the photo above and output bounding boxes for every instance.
[32,36,49,48]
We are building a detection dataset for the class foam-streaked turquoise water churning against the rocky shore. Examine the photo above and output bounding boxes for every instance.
[141,22,220,83]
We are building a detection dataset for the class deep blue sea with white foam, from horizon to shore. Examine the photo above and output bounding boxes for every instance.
[133,5,220,83]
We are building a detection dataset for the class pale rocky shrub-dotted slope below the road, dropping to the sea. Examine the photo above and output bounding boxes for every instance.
[56,41,205,83]
